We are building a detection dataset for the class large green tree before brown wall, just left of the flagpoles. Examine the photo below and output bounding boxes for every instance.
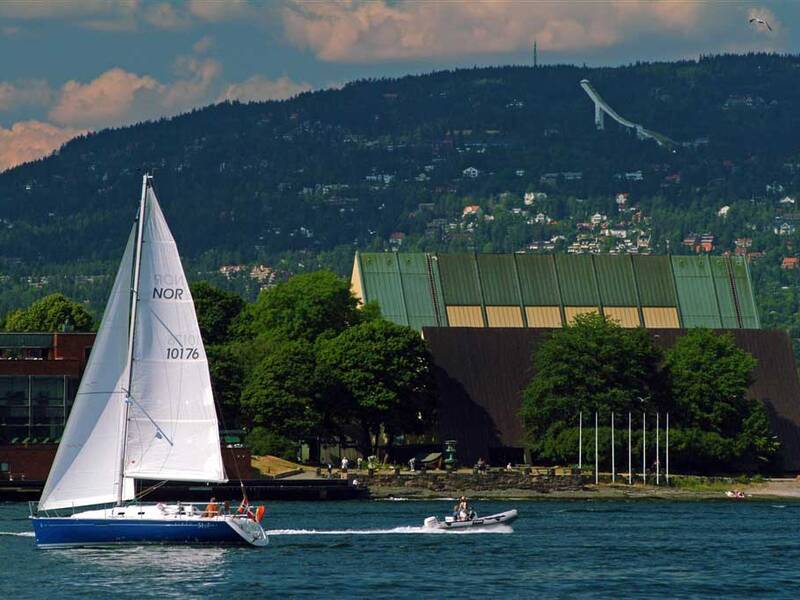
[521,313,664,461]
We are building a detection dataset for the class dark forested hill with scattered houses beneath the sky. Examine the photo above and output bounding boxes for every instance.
[0,54,800,328]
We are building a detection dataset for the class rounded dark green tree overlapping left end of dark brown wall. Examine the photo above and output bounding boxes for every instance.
[318,319,435,456]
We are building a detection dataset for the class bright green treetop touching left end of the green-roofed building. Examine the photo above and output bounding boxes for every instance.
[236,271,360,342]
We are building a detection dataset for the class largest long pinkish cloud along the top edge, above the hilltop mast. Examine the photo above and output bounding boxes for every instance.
[282,0,706,62]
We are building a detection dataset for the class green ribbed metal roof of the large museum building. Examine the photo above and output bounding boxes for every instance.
[354,252,760,330]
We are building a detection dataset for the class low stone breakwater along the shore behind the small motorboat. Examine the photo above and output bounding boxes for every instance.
[359,471,589,498]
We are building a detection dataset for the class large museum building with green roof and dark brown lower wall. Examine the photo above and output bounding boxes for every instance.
[351,252,800,471]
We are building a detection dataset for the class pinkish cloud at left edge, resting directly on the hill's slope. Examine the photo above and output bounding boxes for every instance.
[0,121,81,171]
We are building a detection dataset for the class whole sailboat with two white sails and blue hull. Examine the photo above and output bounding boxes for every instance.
[31,175,268,548]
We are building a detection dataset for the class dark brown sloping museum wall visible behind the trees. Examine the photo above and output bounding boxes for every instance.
[423,327,800,472]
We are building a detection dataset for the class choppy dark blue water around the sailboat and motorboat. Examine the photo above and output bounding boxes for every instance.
[0,501,800,600]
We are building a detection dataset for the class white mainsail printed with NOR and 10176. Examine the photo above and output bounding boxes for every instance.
[125,187,227,482]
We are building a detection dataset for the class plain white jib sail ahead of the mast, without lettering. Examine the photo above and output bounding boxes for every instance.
[39,227,136,510]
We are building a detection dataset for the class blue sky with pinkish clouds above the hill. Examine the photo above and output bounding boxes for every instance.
[0,0,800,171]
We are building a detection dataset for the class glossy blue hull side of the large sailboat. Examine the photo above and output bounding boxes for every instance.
[32,517,247,548]
